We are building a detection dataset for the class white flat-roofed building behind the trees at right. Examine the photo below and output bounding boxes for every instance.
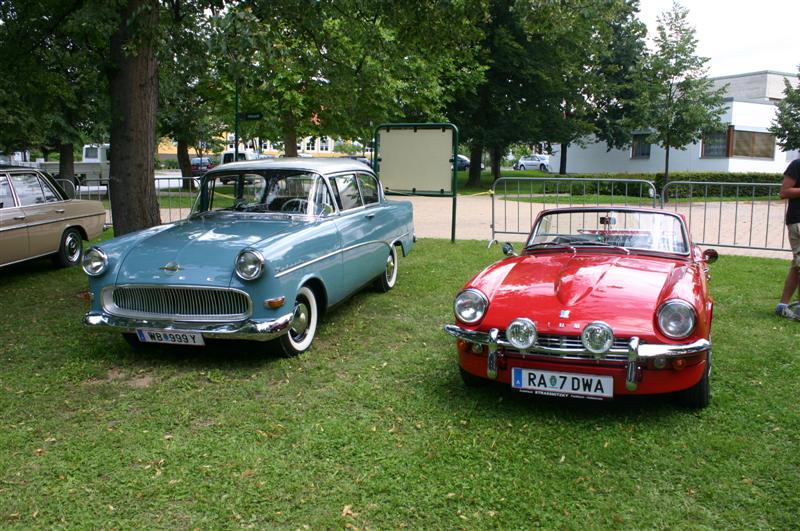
[553,70,798,173]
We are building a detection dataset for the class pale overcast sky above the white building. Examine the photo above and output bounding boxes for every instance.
[639,0,800,77]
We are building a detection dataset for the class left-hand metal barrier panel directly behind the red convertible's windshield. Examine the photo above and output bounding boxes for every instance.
[491,177,658,241]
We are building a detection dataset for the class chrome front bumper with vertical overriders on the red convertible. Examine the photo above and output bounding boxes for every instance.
[444,325,711,391]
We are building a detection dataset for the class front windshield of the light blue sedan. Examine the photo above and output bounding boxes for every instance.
[194,170,334,216]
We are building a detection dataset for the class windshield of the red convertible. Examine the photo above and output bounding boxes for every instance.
[528,210,689,254]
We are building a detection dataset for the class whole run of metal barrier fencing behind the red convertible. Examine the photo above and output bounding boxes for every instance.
[492,177,791,255]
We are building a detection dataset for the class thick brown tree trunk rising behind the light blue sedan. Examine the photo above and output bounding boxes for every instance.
[108,0,161,236]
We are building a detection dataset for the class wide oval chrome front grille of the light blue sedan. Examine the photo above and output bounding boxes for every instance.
[103,286,252,321]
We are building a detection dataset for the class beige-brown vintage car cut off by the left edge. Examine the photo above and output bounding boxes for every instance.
[0,166,106,267]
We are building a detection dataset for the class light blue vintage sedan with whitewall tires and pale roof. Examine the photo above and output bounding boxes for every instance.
[83,158,415,356]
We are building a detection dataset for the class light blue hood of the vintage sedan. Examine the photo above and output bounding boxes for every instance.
[117,216,301,286]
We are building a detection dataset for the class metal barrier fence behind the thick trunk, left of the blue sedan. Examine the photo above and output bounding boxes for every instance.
[56,177,200,229]
